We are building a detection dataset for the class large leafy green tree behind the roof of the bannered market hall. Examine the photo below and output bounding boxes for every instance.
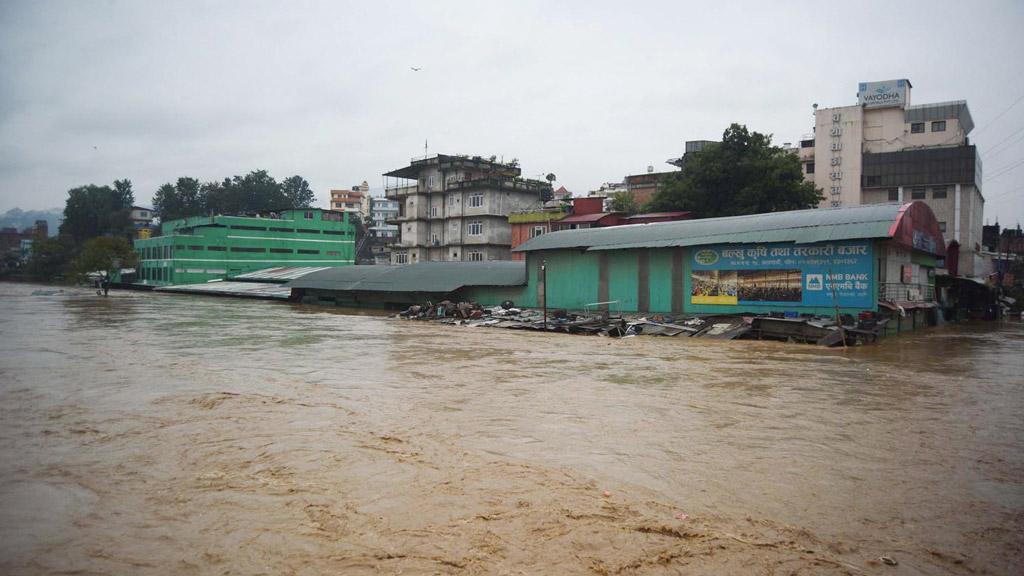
[646,124,823,218]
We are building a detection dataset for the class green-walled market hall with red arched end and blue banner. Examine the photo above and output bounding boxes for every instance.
[515,202,945,315]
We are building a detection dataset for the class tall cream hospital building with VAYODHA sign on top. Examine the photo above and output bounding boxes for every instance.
[798,79,985,276]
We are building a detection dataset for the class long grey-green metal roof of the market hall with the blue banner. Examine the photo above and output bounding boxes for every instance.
[515,204,900,252]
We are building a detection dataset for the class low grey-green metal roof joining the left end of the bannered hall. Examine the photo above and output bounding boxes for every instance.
[286,260,526,293]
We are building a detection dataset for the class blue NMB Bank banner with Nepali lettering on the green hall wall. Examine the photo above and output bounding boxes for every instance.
[690,242,873,308]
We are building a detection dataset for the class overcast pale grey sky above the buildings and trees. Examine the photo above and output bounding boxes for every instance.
[0,0,1024,224]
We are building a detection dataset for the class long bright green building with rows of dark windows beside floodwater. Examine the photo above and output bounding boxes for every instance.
[132,208,355,286]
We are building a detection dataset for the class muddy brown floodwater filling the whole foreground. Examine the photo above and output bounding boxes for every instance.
[0,284,1024,575]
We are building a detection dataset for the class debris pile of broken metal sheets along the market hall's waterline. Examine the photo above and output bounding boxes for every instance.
[396,300,885,346]
